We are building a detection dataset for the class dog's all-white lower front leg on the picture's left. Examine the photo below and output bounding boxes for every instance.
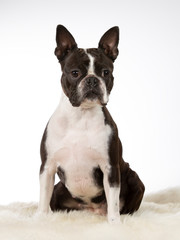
[38,167,55,213]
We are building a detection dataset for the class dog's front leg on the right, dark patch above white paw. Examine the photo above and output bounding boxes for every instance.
[103,166,120,224]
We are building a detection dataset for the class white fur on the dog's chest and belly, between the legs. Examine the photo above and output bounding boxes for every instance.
[46,94,111,198]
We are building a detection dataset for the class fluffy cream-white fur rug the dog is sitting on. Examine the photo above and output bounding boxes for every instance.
[0,187,180,240]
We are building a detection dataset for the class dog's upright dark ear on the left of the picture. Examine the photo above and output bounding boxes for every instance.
[54,25,77,61]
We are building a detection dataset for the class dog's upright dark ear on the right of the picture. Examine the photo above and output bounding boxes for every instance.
[98,27,119,61]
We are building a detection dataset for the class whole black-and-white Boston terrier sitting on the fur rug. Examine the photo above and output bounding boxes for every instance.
[39,25,145,223]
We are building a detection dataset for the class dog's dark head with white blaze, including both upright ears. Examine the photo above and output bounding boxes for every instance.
[55,25,119,108]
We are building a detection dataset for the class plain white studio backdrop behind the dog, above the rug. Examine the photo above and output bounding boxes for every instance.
[0,0,180,204]
